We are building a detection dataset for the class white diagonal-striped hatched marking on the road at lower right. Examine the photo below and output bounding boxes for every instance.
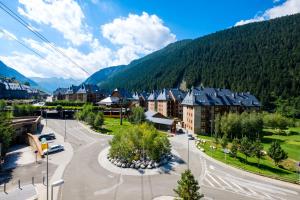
[202,171,295,200]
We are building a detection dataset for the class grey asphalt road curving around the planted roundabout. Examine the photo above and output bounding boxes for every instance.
[48,119,300,200]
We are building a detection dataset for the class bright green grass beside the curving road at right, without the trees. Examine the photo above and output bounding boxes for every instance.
[199,127,300,182]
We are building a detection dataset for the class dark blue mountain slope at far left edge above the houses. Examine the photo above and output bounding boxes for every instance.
[0,60,39,88]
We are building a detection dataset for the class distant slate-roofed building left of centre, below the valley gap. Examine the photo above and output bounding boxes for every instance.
[53,84,107,103]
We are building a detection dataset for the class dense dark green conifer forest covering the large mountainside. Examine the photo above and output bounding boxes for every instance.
[91,14,300,117]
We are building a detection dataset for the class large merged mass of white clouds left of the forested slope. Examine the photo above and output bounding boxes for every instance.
[0,3,176,79]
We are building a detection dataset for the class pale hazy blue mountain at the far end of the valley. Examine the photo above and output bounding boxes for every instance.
[31,77,82,93]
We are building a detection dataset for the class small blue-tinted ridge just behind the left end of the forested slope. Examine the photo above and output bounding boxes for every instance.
[84,65,124,85]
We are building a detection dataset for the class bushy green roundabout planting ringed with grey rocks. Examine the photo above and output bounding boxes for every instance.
[108,123,172,169]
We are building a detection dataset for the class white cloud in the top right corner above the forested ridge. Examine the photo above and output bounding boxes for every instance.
[235,0,300,26]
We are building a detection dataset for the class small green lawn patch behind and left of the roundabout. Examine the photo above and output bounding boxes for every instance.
[99,117,133,134]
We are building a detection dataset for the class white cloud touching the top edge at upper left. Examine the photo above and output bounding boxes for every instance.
[18,0,92,45]
